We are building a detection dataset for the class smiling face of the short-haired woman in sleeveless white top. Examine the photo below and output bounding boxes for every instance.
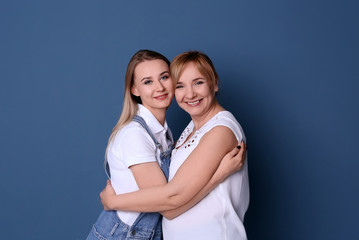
[175,62,218,119]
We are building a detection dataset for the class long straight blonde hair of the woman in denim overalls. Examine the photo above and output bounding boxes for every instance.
[105,49,170,159]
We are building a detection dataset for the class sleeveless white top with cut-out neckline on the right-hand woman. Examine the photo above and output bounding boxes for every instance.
[162,111,249,240]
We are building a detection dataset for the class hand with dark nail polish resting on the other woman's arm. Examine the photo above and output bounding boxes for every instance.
[213,141,247,182]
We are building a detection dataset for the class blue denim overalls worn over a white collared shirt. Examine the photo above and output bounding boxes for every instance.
[86,116,173,240]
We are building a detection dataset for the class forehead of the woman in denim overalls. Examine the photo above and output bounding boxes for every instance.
[135,59,169,77]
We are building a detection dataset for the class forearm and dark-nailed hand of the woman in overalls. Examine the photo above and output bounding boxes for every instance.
[161,141,246,219]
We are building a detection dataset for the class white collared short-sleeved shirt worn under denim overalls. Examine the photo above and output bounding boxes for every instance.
[107,104,169,225]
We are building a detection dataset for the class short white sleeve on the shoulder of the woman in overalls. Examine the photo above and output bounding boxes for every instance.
[115,126,157,167]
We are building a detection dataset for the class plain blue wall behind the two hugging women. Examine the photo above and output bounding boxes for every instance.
[0,0,359,240]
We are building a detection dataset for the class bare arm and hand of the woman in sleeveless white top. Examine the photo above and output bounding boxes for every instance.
[100,126,236,212]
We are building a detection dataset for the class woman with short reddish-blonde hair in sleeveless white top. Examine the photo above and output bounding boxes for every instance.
[101,51,249,240]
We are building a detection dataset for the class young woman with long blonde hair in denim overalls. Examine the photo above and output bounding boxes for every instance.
[87,50,245,240]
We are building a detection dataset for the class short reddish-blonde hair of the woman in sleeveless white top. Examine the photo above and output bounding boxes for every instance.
[170,51,218,86]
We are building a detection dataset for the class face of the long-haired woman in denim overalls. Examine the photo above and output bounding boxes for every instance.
[131,59,174,115]
